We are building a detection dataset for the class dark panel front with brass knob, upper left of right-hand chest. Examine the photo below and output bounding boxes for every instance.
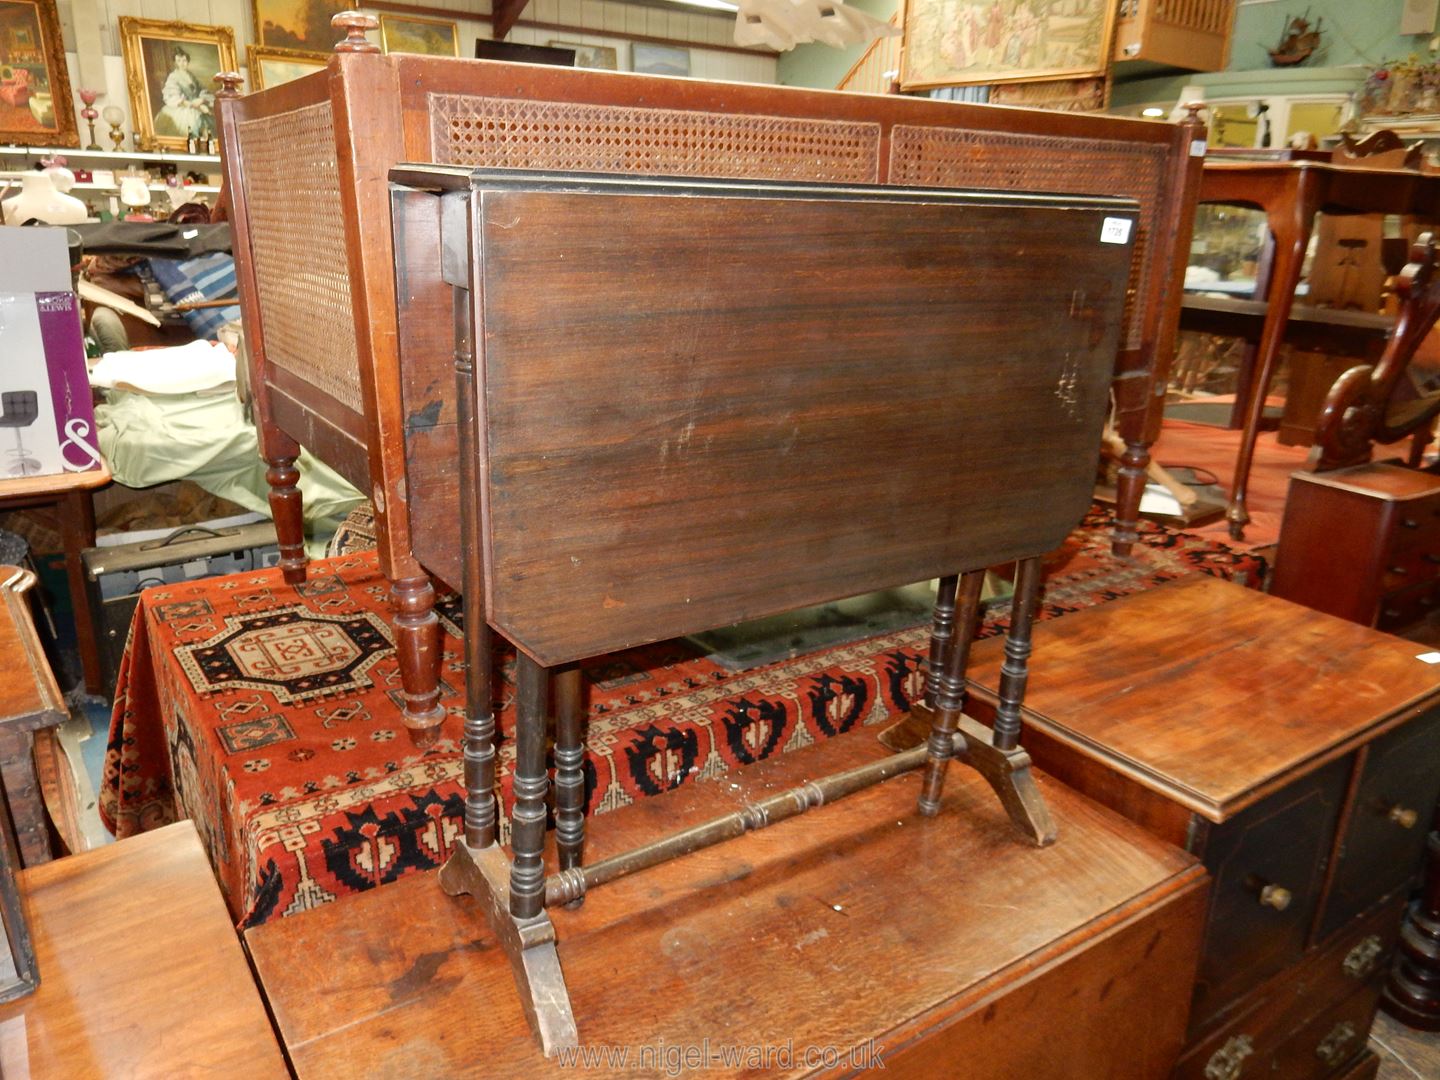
[1191,755,1354,1032]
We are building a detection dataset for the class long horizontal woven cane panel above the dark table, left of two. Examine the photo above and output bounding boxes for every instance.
[429,94,880,183]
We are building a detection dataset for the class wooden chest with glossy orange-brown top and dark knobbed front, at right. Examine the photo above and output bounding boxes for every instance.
[972,579,1440,1080]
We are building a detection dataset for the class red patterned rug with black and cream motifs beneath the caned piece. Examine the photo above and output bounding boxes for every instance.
[101,510,1264,924]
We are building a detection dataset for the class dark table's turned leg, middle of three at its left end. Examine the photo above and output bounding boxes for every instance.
[510,652,550,919]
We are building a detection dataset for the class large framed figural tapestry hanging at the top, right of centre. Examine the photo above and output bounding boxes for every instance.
[900,0,1116,91]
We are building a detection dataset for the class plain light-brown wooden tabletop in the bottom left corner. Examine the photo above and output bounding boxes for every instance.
[0,821,289,1080]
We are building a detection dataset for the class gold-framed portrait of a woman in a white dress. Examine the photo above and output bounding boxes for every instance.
[120,16,238,151]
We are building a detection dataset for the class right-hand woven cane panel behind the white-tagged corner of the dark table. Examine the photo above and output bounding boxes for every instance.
[890,124,1166,348]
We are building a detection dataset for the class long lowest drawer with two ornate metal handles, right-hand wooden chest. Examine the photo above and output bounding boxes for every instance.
[1175,896,1404,1080]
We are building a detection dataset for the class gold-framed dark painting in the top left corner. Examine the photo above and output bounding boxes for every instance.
[0,0,79,147]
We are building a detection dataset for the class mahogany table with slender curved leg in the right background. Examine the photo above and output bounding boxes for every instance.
[1200,161,1440,539]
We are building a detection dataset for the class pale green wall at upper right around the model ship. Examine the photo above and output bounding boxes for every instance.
[1110,0,1430,109]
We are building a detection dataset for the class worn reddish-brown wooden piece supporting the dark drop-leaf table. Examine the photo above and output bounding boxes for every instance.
[246,729,1205,1080]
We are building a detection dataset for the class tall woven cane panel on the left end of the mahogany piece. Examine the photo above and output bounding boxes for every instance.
[239,102,363,412]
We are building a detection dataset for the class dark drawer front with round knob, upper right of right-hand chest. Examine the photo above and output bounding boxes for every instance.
[1318,707,1440,940]
